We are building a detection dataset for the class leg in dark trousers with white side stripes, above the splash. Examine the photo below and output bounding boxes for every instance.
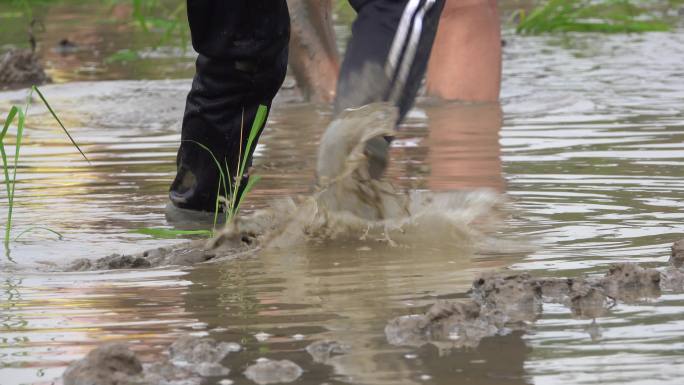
[335,0,444,120]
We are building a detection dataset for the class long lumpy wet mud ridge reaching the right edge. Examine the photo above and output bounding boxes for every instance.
[385,240,684,348]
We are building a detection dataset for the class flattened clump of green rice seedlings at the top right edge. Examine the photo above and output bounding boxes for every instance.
[516,0,671,34]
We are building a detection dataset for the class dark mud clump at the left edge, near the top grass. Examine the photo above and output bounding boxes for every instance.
[0,50,50,88]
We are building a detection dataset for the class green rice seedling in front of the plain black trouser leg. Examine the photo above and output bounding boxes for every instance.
[133,105,268,238]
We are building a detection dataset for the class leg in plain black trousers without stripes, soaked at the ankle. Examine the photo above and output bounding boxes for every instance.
[169,0,290,211]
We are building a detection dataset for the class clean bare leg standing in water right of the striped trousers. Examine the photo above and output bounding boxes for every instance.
[427,0,501,101]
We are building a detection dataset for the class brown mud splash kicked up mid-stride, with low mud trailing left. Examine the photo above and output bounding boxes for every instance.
[68,103,503,271]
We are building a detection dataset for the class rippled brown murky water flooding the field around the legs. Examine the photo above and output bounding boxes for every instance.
[0,2,684,385]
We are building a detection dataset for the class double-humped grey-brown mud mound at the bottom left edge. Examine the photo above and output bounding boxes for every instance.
[62,337,240,385]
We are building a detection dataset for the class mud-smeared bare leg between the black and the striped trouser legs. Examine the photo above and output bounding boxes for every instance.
[287,0,340,103]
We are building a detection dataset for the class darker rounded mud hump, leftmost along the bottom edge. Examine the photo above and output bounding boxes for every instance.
[62,343,145,385]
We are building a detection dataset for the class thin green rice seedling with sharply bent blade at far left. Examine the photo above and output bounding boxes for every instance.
[0,86,90,257]
